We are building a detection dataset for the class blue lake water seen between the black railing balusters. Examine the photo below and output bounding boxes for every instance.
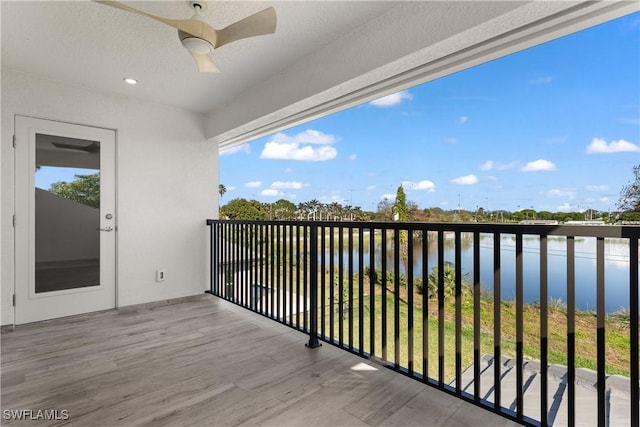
[327,234,638,312]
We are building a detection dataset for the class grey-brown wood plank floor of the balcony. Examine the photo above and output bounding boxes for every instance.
[1,295,516,427]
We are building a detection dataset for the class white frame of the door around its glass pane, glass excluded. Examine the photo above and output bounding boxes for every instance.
[13,114,118,325]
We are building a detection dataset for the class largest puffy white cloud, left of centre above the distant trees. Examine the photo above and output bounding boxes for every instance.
[260,129,338,162]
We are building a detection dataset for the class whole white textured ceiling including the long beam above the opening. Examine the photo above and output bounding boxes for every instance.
[0,0,640,145]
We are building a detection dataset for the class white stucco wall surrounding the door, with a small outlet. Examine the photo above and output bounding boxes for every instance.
[0,68,218,325]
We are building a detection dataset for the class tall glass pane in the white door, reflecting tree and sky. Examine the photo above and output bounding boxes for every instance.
[34,133,100,294]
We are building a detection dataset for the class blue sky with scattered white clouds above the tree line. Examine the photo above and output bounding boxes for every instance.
[220,13,640,211]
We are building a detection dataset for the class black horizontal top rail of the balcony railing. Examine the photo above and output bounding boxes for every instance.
[207,219,640,238]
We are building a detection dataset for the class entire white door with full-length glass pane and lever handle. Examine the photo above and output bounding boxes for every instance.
[15,116,116,324]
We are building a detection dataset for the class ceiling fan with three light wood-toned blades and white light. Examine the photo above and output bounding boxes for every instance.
[94,0,277,73]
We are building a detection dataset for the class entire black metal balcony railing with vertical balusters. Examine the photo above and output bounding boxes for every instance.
[207,220,640,426]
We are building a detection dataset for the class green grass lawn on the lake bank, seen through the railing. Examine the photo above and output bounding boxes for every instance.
[316,288,630,382]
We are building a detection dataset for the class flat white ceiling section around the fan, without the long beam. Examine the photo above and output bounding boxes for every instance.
[2,1,393,113]
